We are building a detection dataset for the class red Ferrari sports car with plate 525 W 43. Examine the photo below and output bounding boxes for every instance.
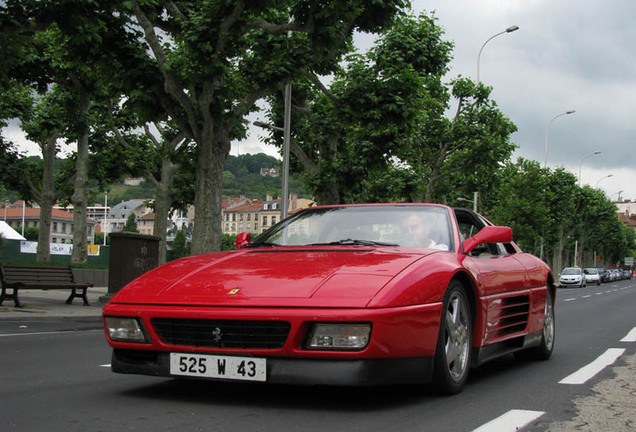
[103,204,556,394]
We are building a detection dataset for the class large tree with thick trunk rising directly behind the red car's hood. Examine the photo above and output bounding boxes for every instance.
[126,0,405,253]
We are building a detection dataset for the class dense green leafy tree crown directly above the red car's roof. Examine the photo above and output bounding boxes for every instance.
[270,14,515,204]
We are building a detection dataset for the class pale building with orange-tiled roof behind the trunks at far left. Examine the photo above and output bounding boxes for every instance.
[2,207,95,244]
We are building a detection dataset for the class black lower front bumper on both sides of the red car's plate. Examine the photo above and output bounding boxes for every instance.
[111,349,433,386]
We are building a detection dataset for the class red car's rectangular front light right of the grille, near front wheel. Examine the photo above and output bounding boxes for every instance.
[307,323,371,351]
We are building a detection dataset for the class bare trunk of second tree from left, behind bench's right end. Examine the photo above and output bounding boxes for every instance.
[71,90,90,264]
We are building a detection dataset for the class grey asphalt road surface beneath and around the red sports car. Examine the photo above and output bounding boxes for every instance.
[0,279,636,432]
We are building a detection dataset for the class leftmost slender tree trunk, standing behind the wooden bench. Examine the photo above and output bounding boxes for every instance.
[36,135,57,262]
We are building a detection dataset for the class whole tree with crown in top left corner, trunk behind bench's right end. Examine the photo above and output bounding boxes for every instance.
[0,0,148,263]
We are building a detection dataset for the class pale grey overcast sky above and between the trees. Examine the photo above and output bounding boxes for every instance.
[5,0,636,200]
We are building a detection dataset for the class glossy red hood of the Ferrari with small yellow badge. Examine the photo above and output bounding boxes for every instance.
[111,247,439,307]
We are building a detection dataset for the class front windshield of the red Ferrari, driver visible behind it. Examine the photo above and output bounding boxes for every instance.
[248,204,452,250]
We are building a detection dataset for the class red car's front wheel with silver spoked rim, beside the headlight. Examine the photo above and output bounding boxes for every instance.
[433,281,473,395]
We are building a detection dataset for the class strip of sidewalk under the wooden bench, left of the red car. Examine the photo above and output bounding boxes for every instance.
[0,287,108,320]
